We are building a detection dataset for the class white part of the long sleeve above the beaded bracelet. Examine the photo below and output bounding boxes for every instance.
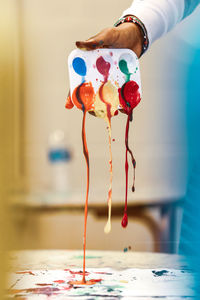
[123,0,185,45]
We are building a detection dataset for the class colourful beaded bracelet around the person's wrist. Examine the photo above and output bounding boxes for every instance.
[114,16,149,56]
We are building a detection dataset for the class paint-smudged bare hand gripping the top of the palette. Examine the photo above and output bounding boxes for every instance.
[76,22,143,58]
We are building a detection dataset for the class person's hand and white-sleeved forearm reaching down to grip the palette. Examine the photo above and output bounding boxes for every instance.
[76,0,200,57]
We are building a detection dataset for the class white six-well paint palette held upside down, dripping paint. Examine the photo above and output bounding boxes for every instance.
[68,49,141,118]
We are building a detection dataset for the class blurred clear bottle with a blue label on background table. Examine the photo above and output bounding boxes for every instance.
[48,130,72,192]
